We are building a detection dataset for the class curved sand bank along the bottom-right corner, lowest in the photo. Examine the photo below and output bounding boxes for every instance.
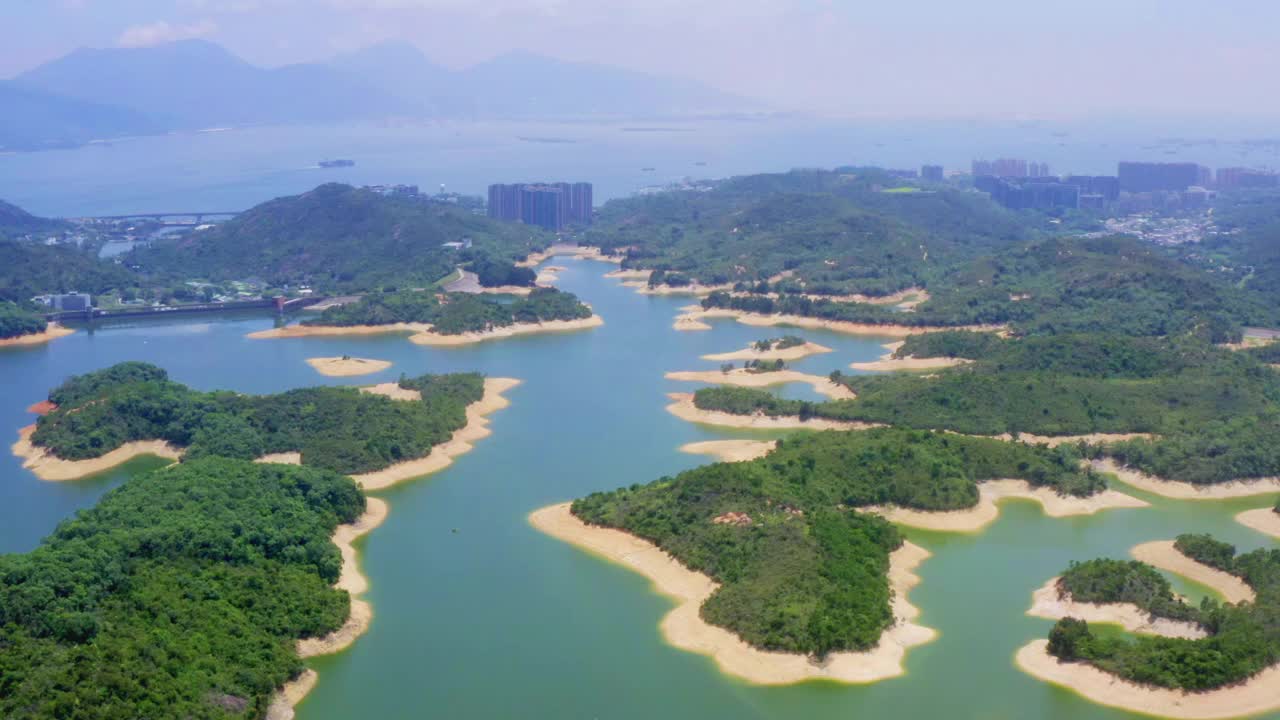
[1014,639,1280,720]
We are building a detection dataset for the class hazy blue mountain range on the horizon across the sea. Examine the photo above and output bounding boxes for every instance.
[0,40,763,150]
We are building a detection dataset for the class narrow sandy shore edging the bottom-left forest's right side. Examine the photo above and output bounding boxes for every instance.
[266,497,388,720]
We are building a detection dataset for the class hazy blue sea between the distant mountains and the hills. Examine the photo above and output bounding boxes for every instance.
[0,118,1280,217]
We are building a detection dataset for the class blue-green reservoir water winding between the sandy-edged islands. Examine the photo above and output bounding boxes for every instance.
[0,260,1280,720]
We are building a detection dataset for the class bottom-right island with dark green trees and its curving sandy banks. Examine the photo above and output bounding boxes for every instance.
[1016,534,1280,720]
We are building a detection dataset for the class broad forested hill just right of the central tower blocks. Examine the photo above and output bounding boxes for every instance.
[586,170,1043,295]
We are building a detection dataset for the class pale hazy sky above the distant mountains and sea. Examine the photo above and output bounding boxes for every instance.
[0,0,1280,118]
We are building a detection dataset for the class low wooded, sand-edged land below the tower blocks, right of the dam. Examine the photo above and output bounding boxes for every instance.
[248,287,604,346]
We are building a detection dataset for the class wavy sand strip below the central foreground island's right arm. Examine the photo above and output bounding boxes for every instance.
[860,480,1147,533]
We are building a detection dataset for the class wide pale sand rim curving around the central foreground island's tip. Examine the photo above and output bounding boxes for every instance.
[529,502,937,685]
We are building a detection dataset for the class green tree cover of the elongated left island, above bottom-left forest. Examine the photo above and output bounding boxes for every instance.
[23,363,484,474]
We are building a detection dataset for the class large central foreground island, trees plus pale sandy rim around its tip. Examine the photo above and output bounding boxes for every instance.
[531,428,1126,684]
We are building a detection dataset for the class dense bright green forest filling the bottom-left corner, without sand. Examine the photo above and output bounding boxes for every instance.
[0,457,365,720]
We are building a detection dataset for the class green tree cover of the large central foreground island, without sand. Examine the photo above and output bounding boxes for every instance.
[535,428,1105,664]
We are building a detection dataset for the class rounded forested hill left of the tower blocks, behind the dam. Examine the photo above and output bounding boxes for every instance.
[128,183,553,292]
